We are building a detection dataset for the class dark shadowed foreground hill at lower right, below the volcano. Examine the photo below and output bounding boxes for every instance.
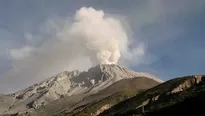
[99,75,205,116]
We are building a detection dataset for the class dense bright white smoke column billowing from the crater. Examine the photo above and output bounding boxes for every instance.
[70,7,127,64]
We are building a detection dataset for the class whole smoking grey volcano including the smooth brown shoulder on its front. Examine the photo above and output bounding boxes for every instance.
[0,64,163,115]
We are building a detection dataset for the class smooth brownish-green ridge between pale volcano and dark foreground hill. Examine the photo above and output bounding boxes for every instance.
[55,77,159,116]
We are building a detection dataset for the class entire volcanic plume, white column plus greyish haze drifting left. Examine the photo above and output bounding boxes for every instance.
[2,7,146,93]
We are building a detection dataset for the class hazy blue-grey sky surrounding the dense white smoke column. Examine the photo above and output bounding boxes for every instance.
[0,0,205,93]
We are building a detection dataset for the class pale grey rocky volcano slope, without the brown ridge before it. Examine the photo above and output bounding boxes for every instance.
[0,65,163,114]
